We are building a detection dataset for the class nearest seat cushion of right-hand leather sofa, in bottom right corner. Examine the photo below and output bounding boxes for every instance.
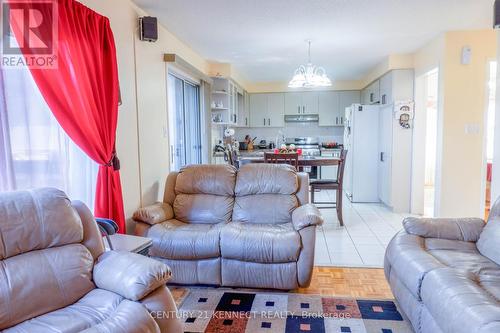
[422,268,500,333]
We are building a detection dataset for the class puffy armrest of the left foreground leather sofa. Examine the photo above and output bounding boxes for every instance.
[93,251,171,301]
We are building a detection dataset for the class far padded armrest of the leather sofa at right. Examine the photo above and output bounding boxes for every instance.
[403,217,485,242]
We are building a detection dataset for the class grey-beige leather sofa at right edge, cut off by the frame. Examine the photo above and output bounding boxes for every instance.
[385,201,500,333]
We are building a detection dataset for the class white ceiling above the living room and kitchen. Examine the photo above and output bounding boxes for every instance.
[134,0,494,82]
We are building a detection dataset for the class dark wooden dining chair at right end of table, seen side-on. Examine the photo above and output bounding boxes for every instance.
[309,149,347,226]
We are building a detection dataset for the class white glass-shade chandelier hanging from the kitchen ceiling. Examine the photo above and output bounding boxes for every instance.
[288,40,332,88]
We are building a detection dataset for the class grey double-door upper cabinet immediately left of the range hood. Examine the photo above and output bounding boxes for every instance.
[250,93,285,127]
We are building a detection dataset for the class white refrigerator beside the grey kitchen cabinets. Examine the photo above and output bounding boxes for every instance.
[344,104,380,202]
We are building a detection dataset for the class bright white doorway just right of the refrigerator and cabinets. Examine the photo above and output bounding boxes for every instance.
[412,68,439,217]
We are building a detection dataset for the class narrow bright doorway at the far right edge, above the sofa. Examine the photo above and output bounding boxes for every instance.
[484,61,497,218]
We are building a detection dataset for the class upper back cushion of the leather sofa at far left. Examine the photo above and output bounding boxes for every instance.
[0,188,83,260]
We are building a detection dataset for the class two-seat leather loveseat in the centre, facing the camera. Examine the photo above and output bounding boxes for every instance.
[134,164,323,290]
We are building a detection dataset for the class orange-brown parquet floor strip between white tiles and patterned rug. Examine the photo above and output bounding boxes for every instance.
[294,266,394,299]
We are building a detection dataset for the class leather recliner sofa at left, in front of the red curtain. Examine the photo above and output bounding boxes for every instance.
[0,188,182,333]
